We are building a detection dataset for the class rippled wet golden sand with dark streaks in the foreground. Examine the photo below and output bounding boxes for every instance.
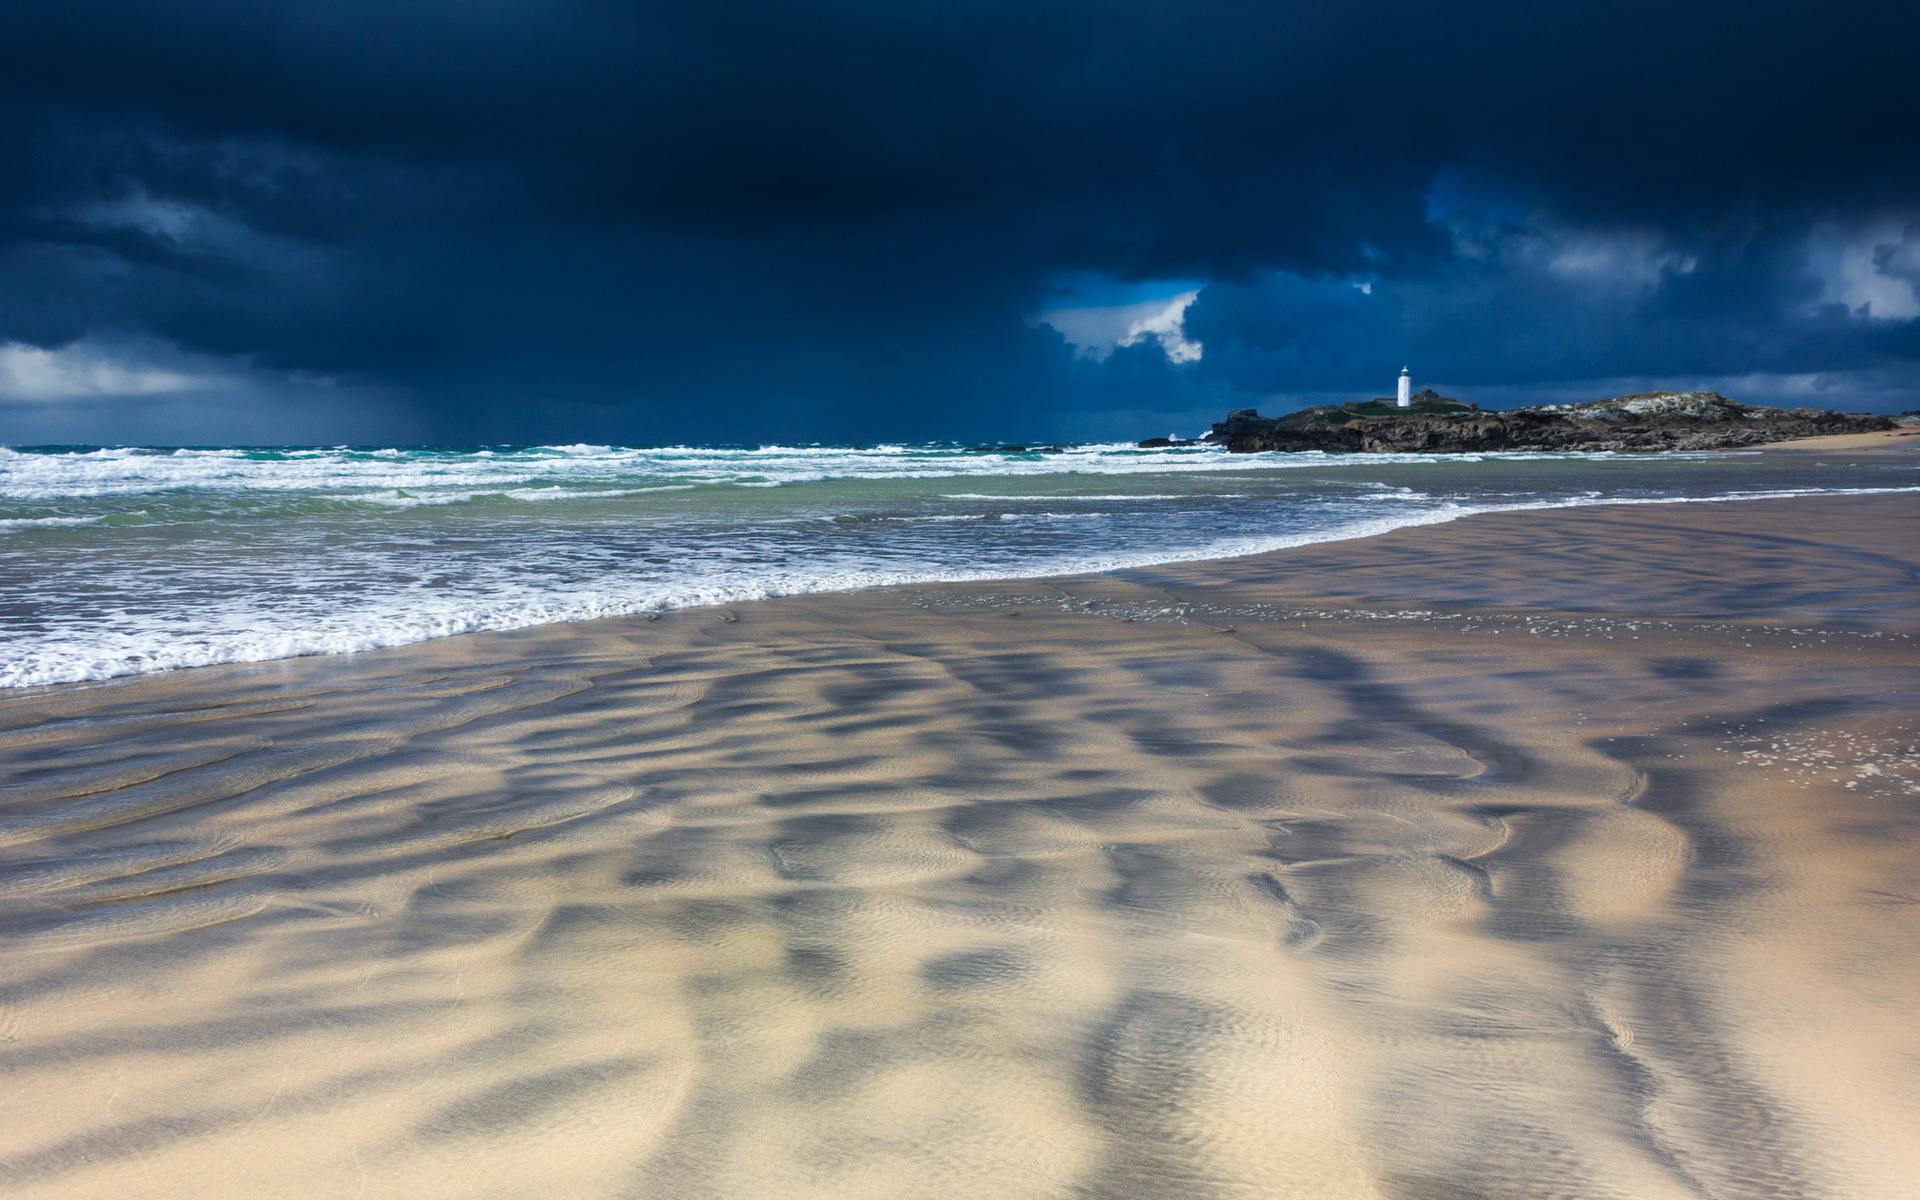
[0,495,1920,1200]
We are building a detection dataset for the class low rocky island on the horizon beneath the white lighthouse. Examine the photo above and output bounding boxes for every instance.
[1204,390,1895,453]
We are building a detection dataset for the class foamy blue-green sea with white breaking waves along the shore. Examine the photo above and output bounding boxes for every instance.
[0,444,1920,687]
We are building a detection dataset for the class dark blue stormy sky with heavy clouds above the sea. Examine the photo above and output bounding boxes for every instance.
[0,0,1920,444]
